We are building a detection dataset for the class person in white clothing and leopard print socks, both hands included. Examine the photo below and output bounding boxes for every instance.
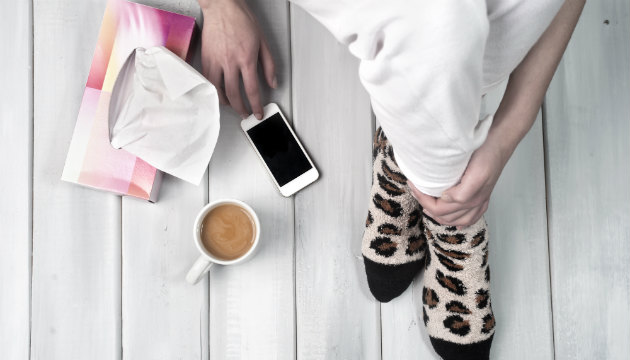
[199,0,585,360]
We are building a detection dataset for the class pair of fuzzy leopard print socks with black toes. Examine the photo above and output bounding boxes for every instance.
[362,128,495,360]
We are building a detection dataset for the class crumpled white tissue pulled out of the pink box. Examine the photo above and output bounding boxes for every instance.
[109,46,220,185]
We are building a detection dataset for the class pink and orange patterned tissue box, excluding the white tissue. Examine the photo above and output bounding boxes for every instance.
[61,0,195,202]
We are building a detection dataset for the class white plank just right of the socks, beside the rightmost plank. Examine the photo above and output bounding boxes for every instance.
[485,84,553,360]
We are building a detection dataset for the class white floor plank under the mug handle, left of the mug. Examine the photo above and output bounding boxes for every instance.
[122,0,208,360]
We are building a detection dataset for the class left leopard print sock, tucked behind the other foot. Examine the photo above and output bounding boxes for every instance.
[361,127,426,302]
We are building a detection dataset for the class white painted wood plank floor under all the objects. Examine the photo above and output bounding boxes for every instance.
[0,0,630,360]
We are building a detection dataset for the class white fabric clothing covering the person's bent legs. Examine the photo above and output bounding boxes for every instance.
[291,0,563,197]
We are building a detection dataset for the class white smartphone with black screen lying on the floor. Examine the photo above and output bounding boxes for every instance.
[241,103,319,196]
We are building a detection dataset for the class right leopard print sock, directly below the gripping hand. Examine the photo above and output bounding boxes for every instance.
[422,213,495,360]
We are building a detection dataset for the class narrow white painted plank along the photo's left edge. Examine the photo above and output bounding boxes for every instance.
[0,1,33,359]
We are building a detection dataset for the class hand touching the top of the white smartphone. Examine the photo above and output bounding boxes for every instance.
[199,0,277,120]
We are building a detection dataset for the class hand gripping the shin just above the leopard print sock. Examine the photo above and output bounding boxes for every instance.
[408,137,511,229]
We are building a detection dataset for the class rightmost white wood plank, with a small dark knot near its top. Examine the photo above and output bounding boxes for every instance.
[545,0,630,359]
